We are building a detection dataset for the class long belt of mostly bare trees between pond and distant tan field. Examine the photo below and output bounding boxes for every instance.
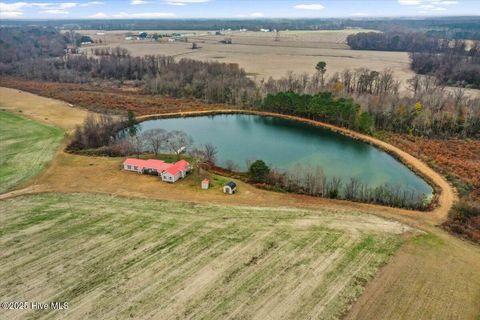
[0,27,480,137]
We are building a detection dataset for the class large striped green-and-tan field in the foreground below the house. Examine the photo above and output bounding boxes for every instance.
[0,193,409,319]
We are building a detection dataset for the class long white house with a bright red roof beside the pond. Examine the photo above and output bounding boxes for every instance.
[123,158,192,183]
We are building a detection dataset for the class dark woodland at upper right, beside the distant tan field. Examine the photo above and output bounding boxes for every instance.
[347,32,480,88]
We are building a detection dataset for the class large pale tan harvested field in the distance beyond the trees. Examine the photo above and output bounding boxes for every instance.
[81,29,413,84]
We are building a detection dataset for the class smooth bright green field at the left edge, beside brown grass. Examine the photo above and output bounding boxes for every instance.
[0,111,63,193]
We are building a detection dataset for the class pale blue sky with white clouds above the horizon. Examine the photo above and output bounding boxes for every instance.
[0,0,480,19]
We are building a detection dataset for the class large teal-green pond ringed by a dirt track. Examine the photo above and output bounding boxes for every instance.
[140,114,432,195]
